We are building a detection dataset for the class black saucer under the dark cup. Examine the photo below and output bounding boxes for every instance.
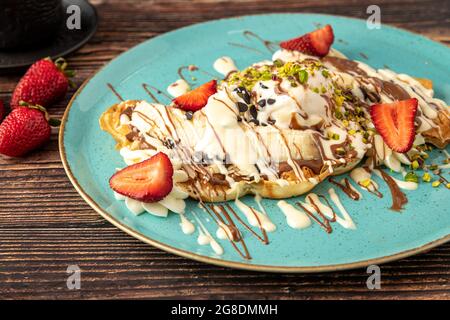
[0,0,97,71]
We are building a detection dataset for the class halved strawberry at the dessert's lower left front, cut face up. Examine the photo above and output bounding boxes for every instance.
[109,152,173,202]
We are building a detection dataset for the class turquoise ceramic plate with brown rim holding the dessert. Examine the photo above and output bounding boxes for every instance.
[60,14,450,272]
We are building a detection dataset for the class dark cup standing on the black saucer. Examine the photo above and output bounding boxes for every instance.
[0,0,63,49]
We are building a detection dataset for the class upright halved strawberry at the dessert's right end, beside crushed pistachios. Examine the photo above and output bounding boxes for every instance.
[370,98,417,153]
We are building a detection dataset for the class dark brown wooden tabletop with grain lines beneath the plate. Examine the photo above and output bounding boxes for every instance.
[0,0,450,299]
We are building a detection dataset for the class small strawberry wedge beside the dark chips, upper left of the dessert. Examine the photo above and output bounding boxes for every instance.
[172,80,217,111]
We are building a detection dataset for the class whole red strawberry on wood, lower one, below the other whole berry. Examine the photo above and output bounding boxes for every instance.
[0,106,58,157]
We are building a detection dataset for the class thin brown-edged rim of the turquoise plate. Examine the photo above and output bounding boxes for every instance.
[58,12,450,273]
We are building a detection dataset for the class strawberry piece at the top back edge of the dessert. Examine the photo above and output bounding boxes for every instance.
[280,24,334,57]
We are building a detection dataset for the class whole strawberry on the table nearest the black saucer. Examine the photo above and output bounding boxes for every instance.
[11,58,73,109]
